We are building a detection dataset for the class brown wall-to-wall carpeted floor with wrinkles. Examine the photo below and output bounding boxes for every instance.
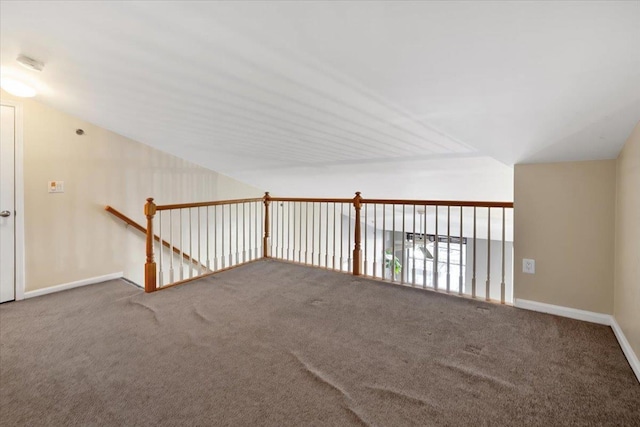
[0,261,640,426]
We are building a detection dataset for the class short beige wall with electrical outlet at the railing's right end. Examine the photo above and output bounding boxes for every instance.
[514,160,616,314]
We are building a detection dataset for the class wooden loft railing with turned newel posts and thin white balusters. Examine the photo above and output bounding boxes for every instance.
[145,193,513,303]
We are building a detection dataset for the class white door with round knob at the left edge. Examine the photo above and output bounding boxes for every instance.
[0,105,16,302]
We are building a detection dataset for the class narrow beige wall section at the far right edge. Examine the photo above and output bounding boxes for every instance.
[613,123,640,356]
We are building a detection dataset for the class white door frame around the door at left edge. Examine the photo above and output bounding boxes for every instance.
[0,99,25,301]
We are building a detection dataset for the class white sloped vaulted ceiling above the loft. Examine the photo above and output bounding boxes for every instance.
[0,1,640,200]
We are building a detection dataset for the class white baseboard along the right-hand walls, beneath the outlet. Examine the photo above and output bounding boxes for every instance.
[513,298,640,382]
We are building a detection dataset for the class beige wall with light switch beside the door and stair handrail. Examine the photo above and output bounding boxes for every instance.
[1,92,263,291]
